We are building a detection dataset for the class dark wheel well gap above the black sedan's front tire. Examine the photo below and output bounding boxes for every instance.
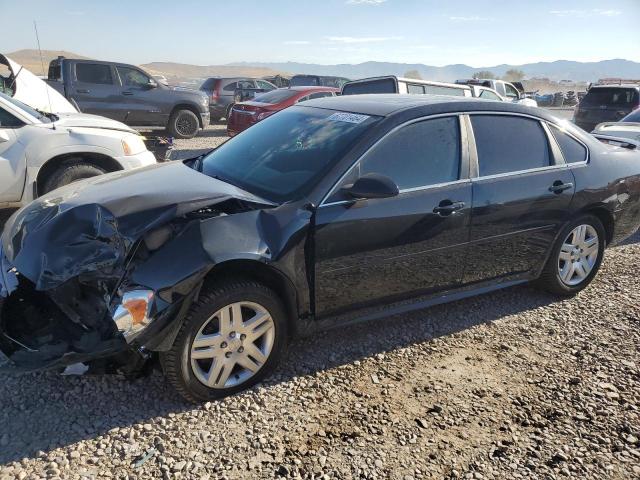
[205,260,298,333]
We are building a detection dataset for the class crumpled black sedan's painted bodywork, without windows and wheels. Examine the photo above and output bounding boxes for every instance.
[0,95,640,370]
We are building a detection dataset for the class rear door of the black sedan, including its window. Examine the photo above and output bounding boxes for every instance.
[464,114,575,283]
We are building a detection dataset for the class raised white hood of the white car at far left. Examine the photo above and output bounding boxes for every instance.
[0,54,77,114]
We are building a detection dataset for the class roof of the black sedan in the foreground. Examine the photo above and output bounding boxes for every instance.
[304,93,549,118]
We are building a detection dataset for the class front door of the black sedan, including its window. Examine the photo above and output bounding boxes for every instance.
[314,116,471,317]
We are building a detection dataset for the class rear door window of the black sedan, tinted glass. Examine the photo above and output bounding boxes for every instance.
[471,115,551,177]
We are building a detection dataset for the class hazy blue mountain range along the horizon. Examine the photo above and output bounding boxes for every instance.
[231,59,640,82]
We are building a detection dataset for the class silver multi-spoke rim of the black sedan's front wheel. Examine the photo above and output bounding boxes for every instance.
[189,302,275,389]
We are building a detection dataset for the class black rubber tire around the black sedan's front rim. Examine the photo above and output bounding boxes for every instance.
[160,280,288,403]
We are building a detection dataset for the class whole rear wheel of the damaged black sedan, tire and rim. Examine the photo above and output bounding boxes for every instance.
[538,215,606,296]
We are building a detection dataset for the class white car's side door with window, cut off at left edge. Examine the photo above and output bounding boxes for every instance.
[0,105,26,203]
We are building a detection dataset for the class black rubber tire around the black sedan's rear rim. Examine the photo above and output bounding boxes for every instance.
[536,214,607,296]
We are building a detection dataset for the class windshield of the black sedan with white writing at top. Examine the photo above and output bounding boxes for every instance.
[201,106,380,203]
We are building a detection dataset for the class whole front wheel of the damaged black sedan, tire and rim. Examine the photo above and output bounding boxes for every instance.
[160,281,287,402]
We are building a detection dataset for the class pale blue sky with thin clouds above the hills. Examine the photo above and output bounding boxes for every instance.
[5,0,640,67]
